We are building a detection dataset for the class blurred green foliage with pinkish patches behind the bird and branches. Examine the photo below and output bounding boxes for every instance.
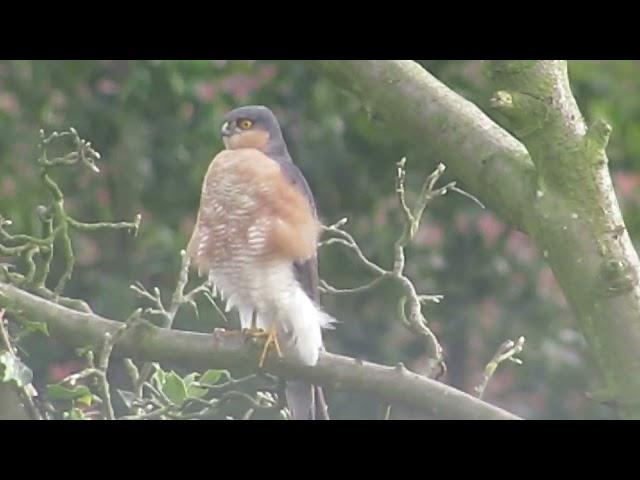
[0,60,640,418]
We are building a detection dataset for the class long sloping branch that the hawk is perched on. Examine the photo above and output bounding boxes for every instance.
[0,282,518,420]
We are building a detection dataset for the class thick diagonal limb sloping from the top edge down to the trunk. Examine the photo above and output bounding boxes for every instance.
[309,60,535,230]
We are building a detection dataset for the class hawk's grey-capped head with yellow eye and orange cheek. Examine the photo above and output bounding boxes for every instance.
[220,105,286,152]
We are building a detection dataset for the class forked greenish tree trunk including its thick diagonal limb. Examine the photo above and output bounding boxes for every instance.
[310,60,640,418]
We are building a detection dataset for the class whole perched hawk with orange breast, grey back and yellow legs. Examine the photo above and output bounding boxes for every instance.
[187,105,335,420]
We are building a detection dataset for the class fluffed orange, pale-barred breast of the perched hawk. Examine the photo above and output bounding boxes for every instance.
[189,149,318,280]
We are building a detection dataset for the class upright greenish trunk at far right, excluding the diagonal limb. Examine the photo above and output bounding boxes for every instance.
[490,60,640,418]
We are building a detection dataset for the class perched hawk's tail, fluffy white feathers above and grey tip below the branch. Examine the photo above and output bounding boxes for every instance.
[285,288,336,420]
